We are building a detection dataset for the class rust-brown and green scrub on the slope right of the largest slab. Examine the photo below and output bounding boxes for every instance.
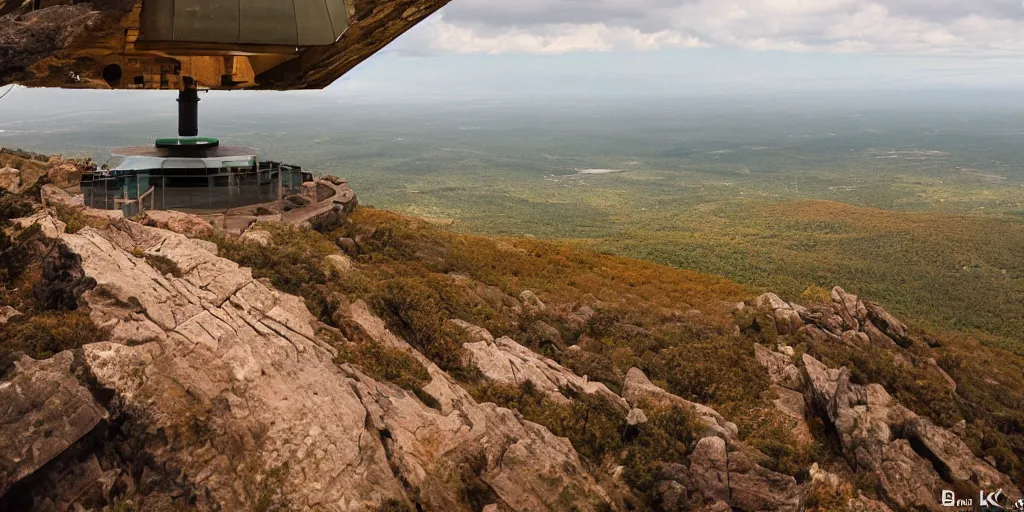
[205,208,1024,489]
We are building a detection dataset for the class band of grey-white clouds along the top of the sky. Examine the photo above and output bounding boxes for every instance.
[399,0,1024,57]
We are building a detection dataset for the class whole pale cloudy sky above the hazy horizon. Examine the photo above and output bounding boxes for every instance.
[319,0,1024,96]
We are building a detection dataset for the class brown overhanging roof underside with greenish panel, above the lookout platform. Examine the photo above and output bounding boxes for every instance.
[0,0,449,90]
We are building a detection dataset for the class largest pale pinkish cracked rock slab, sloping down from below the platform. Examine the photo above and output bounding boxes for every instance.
[62,223,404,510]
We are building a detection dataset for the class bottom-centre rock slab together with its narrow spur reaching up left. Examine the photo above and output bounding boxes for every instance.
[350,301,614,510]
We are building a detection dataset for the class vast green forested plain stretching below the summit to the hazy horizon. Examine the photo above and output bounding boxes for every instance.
[0,91,1024,353]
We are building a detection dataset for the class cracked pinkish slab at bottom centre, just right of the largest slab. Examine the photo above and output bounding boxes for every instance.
[354,366,610,511]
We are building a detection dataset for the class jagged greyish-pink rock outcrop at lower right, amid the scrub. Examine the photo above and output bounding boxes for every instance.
[734,287,1019,510]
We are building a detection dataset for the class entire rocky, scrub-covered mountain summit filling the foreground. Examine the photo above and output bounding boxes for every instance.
[0,171,1020,511]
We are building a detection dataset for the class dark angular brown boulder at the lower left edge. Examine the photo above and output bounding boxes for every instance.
[0,351,108,496]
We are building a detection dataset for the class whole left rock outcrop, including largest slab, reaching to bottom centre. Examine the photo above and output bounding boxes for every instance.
[0,213,610,510]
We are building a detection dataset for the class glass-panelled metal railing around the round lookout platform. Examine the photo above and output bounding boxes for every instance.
[81,162,306,216]
